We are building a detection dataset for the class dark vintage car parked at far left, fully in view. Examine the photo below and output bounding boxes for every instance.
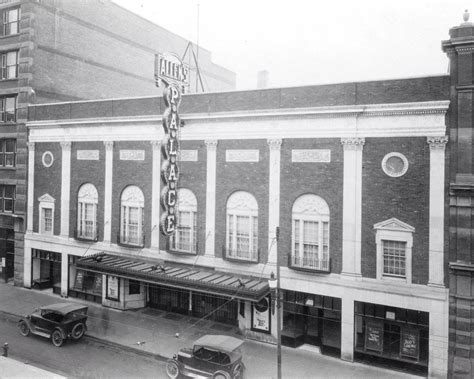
[18,303,87,347]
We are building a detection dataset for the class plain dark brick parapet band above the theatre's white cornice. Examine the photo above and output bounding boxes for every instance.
[28,75,450,121]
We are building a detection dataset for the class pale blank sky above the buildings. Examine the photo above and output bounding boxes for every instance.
[113,0,474,90]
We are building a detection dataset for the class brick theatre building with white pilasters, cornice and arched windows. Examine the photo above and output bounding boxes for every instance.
[24,76,450,377]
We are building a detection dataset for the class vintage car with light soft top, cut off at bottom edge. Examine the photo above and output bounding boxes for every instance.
[166,335,245,379]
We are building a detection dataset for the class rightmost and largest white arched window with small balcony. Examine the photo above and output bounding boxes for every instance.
[291,194,330,271]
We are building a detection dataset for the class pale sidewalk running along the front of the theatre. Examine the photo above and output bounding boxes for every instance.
[0,283,422,378]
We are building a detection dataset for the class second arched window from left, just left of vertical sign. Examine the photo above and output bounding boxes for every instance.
[120,186,145,247]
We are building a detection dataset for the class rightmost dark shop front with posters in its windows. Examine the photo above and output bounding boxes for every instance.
[355,302,429,373]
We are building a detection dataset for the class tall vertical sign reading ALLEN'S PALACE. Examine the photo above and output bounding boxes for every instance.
[155,53,189,236]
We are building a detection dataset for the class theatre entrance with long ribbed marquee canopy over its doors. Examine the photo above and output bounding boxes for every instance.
[75,253,269,326]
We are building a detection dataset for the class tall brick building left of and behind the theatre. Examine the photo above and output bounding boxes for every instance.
[0,0,235,284]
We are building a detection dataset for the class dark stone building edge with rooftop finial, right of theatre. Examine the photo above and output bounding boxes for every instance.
[443,15,474,378]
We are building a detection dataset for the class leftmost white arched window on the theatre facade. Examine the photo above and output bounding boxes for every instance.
[76,183,99,240]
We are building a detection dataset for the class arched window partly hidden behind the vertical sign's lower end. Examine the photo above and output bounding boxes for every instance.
[171,188,197,254]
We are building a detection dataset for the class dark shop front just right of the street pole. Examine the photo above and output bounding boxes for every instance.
[281,290,341,355]
